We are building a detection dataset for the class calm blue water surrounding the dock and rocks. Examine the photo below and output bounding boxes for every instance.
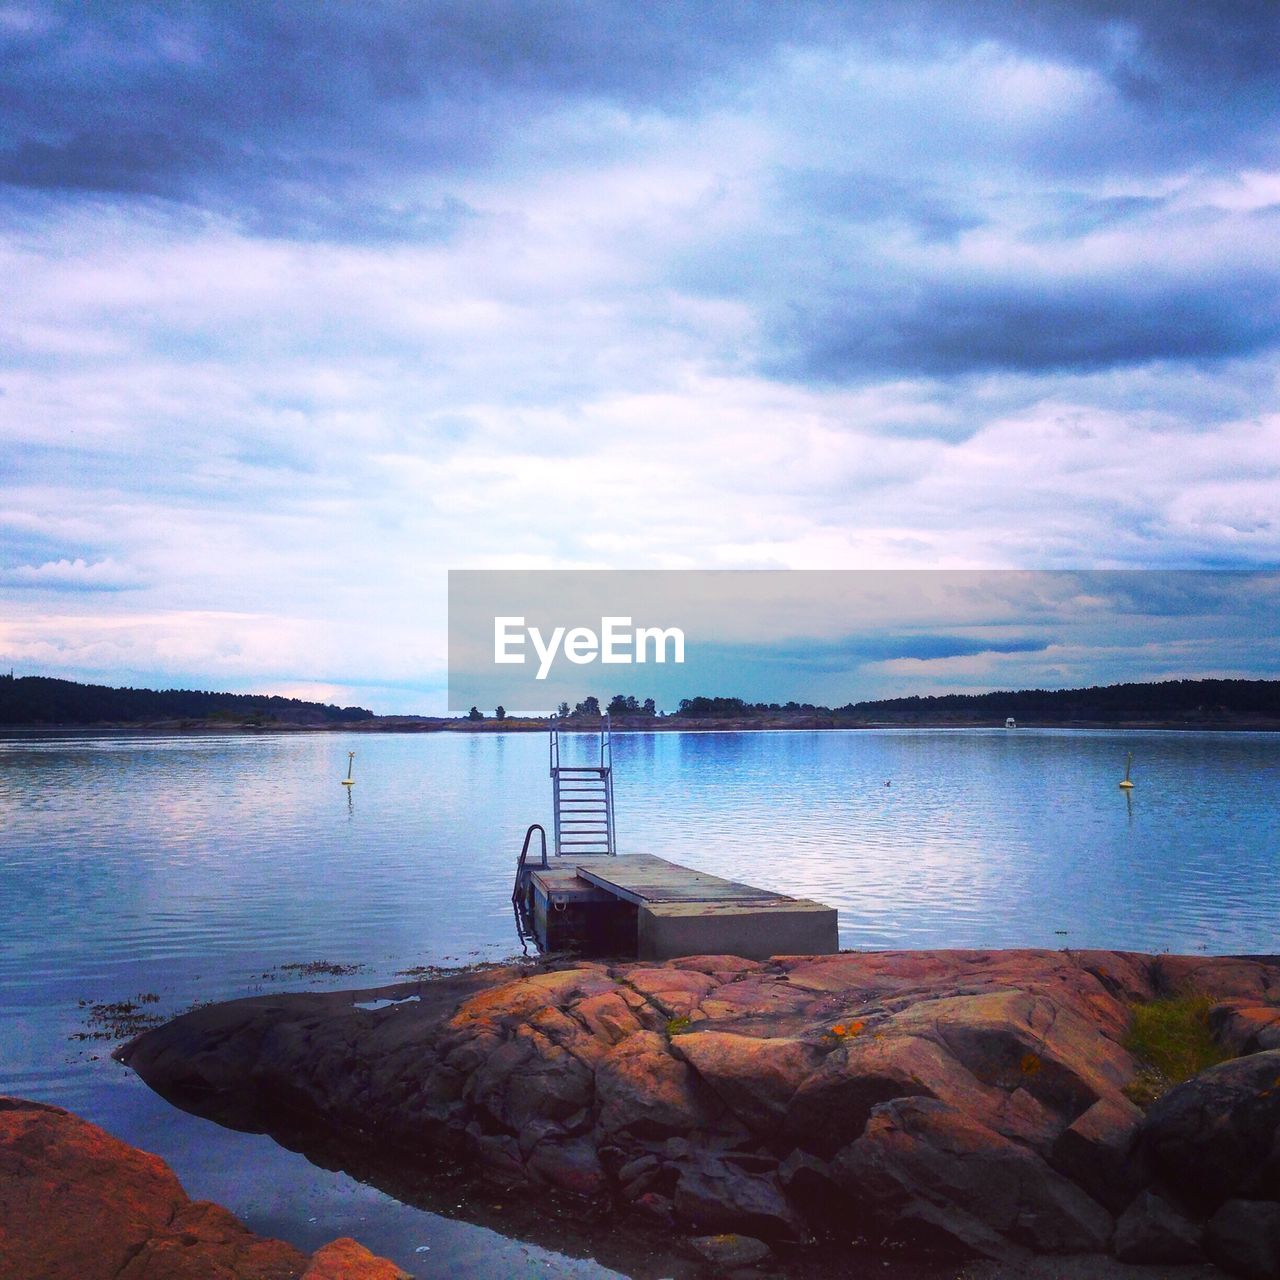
[0,730,1280,1276]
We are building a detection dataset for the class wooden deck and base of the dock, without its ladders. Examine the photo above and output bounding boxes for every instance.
[527,854,840,960]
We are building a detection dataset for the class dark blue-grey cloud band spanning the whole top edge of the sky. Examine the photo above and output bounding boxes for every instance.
[0,0,1280,207]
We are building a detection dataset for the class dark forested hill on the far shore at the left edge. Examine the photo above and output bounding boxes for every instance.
[0,676,374,724]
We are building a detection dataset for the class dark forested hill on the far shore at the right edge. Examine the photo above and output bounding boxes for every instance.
[835,680,1280,727]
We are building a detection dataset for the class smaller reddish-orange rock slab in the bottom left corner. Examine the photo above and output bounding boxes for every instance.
[0,1097,408,1280]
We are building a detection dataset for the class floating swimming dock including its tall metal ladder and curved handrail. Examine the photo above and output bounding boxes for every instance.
[511,716,840,960]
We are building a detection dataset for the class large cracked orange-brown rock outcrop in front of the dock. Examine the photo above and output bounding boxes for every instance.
[110,951,1280,1280]
